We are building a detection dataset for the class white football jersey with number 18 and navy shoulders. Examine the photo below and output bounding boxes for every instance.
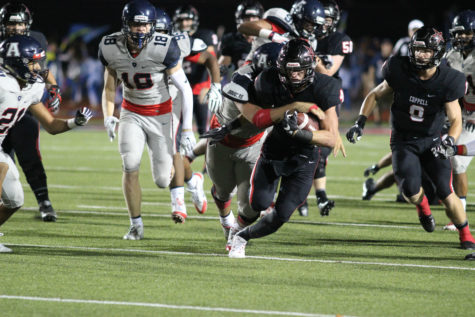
[99,32,181,105]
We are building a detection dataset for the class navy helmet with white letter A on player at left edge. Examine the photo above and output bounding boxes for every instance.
[0,35,48,84]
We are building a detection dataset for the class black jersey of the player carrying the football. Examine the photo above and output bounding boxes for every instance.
[249,67,342,160]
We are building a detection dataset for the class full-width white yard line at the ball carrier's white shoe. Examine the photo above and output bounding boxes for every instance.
[3,243,475,271]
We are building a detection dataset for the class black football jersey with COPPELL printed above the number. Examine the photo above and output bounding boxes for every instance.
[383,56,465,137]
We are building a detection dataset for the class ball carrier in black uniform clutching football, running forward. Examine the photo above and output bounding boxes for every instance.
[229,39,341,258]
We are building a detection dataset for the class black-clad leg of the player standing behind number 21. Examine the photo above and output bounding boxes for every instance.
[9,112,57,222]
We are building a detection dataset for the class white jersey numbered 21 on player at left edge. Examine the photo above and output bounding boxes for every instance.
[0,67,45,144]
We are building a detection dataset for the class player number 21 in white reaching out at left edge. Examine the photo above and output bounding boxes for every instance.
[0,35,92,252]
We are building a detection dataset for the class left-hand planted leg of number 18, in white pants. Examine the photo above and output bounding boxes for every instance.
[119,109,146,240]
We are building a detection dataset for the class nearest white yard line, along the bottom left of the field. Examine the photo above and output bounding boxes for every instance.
[0,295,343,317]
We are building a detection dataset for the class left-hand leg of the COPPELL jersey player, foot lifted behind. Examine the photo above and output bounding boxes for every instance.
[391,141,435,232]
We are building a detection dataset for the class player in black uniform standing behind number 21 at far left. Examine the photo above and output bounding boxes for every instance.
[0,3,61,221]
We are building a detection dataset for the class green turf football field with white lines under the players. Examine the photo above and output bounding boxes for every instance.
[0,129,475,316]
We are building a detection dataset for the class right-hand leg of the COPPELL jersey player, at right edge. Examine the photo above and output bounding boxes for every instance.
[424,151,475,249]
